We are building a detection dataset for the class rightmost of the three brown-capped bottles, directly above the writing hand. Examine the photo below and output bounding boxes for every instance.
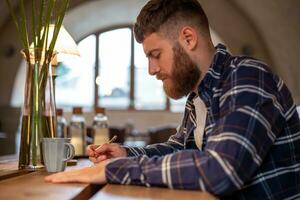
[93,107,109,144]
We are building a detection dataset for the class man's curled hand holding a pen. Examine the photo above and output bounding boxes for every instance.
[86,143,127,164]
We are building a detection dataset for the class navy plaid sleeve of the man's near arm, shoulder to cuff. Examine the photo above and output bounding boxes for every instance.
[106,60,288,195]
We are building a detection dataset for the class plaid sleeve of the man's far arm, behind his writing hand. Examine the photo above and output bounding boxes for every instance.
[124,126,184,157]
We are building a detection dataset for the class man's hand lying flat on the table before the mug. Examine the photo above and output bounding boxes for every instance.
[45,160,109,184]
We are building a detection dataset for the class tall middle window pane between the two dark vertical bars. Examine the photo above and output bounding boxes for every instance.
[96,28,131,109]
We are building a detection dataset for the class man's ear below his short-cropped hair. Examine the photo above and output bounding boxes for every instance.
[179,26,198,50]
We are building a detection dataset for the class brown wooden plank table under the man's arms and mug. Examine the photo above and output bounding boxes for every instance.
[0,159,215,200]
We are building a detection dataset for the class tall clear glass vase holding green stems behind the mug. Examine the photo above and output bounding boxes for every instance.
[19,49,56,170]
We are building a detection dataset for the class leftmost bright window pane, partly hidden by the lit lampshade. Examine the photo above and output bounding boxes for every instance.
[55,35,96,107]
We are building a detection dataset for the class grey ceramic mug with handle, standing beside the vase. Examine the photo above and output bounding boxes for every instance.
[42,138,75,172]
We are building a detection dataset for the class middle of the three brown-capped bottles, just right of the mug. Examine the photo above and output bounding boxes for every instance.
[69,107,86,156]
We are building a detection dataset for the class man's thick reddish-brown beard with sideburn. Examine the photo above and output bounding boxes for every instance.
[164,42,201,99]
